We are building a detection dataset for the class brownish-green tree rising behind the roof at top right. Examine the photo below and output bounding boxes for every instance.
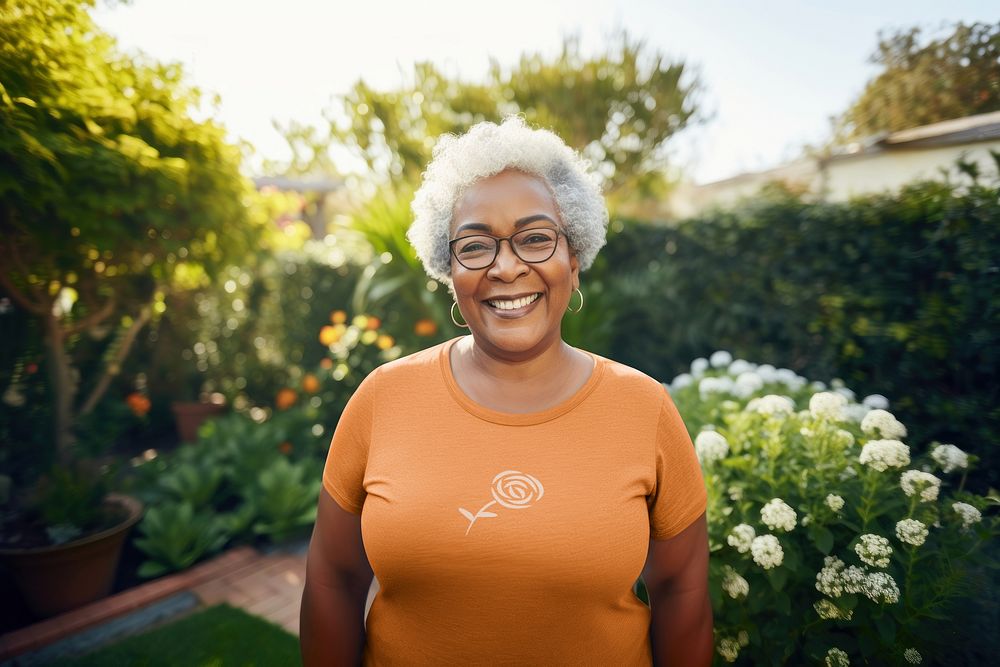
[836,22,1000,143]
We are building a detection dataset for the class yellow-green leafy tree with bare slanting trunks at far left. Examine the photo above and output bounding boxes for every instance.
[0,0,263,463]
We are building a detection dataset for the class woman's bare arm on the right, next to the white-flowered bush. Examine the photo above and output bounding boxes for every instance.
[643,514,713,667]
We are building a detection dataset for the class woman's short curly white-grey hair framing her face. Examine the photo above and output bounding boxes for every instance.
[406,116,608,288]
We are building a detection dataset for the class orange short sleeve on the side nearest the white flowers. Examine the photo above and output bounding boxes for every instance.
[648,389,708,540]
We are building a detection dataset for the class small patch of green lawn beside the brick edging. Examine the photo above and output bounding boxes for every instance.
[59,604,301,667]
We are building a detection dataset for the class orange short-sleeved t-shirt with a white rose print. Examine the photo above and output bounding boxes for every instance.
[323,338,706,667]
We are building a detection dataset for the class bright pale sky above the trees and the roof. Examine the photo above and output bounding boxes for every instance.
[94,0,1000,183]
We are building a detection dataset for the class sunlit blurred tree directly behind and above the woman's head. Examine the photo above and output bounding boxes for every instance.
[285,33,700,198]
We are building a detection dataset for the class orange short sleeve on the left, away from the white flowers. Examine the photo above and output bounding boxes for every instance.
[323,369,378,514]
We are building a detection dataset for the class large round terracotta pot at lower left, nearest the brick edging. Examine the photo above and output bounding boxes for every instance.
[0,493,143,617]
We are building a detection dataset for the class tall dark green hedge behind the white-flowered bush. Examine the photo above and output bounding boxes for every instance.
[596,177,1000,486]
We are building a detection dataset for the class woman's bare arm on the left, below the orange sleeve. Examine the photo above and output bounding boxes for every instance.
[299,489,372,667]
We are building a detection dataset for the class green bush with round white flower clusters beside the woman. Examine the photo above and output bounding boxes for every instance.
[669,351,998,665]
